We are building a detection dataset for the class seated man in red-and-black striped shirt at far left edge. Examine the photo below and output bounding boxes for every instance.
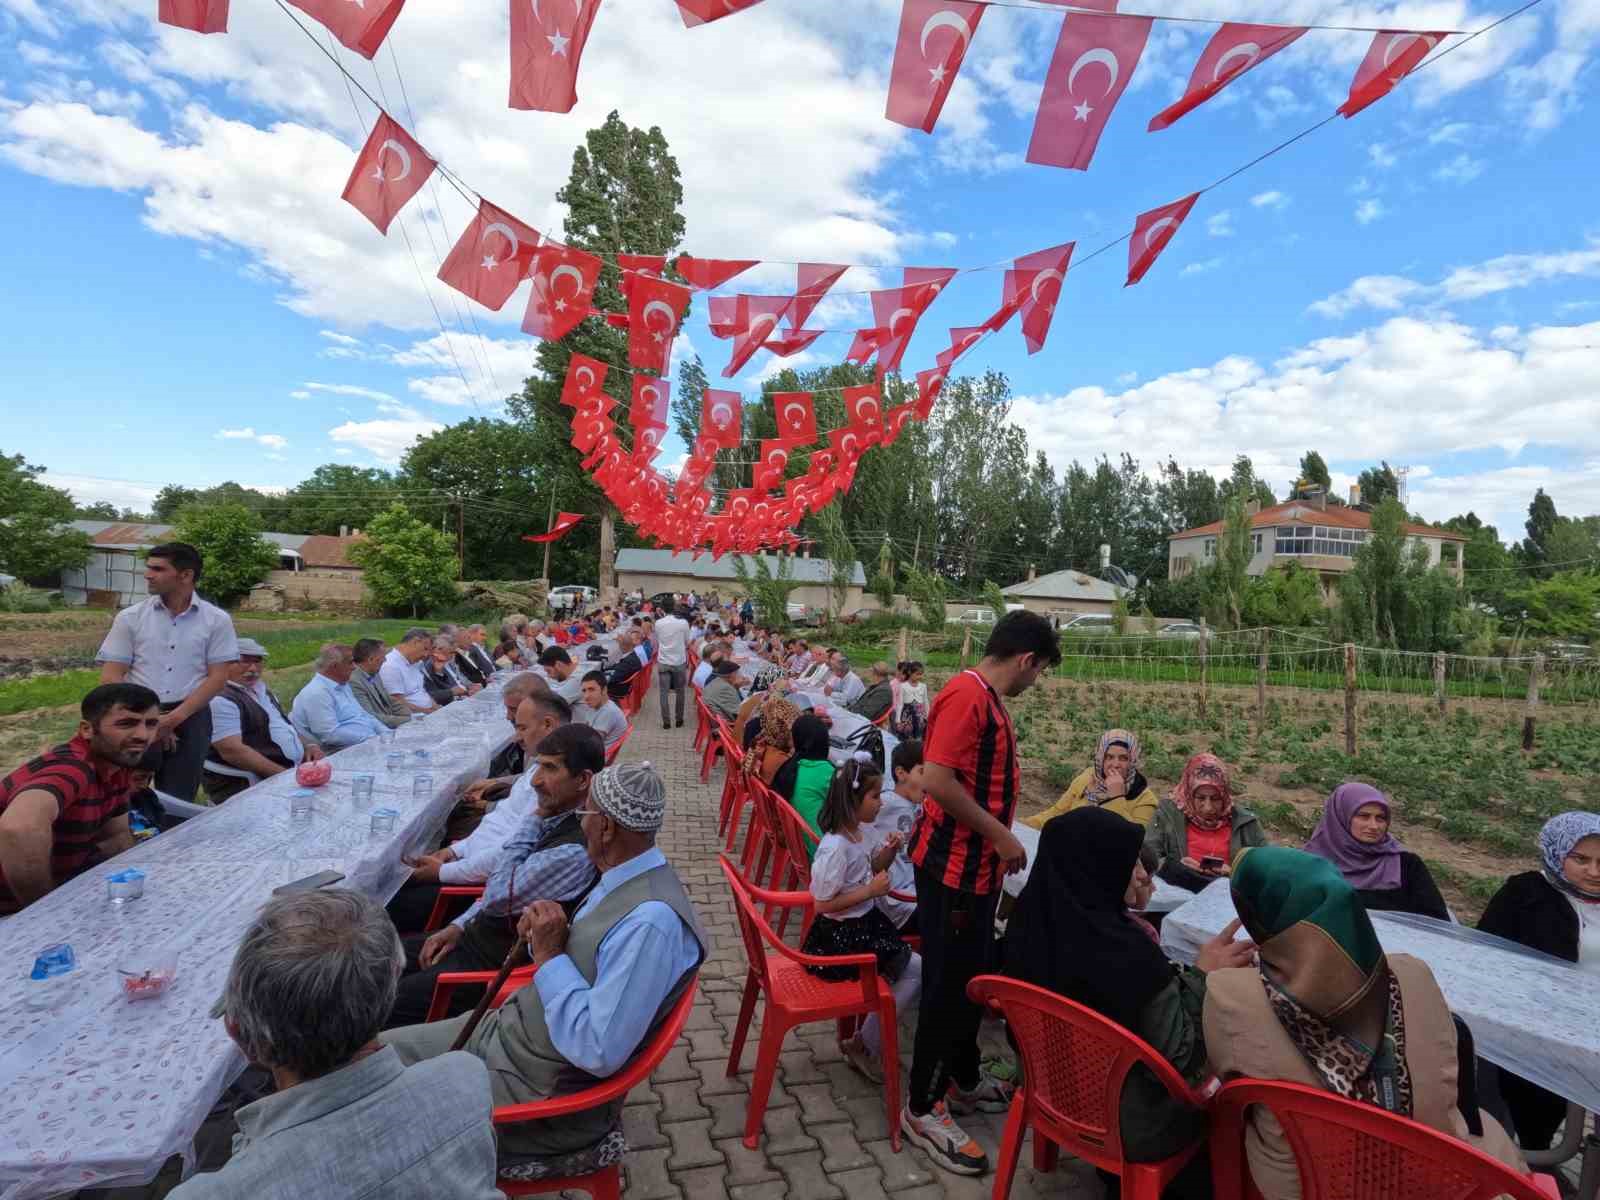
[0,683,162,915]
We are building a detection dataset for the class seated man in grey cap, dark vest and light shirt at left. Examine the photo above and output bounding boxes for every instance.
[202,637,322,803]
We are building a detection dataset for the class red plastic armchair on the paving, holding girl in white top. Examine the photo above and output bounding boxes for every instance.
[718,854,899,1152]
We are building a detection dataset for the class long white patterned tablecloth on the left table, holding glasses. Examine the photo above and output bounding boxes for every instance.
[0,682,512,1200]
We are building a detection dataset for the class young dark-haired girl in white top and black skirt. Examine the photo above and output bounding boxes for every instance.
[802,750,922,1083]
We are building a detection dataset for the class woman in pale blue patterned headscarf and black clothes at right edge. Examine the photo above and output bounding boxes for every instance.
[1478,813,1600,1150]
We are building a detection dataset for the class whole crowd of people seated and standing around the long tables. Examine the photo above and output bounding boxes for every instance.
[0,563,1600,1200]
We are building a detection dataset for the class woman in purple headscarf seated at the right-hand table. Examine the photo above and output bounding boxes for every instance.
[1306,781,1450,920]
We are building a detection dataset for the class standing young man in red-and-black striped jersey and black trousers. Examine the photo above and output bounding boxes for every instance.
[901,611,1061,1174]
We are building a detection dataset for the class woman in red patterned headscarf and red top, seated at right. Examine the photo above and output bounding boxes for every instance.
[1144,754,1267,891]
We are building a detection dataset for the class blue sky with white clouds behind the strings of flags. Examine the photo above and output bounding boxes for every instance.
[0,0,1600,536]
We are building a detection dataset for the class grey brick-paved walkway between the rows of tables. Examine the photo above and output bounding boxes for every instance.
[622,694,1101,1200]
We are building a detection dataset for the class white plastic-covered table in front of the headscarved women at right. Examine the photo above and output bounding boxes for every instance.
[1162,880,1600,1110]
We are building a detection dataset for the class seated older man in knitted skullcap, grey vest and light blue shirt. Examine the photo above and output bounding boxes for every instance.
[381,763,706,1179]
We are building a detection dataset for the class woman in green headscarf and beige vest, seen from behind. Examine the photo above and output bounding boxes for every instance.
[1205,846,1526,1200]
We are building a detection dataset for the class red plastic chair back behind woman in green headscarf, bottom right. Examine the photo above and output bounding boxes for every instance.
[1211,1078,1558,1200]
